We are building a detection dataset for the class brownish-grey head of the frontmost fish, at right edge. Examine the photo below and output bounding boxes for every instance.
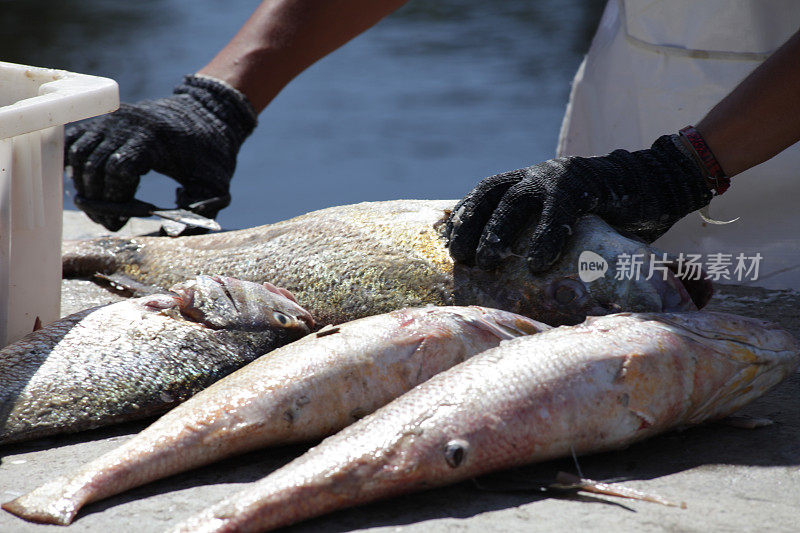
[639,312,800,423]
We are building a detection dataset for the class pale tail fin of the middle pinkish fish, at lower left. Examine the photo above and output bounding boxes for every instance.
[2,477,83,526]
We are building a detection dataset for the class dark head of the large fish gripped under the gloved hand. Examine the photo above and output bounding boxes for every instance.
[454,215,711,325]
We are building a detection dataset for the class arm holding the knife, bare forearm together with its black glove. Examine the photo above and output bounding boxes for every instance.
[65,0,406,227]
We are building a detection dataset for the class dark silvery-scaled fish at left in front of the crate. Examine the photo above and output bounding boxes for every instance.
[0,276,313,444]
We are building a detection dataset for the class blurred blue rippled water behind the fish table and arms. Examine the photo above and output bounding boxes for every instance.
[0,0,604,228]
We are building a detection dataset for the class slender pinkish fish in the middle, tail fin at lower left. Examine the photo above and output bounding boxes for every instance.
[3,307,550,525]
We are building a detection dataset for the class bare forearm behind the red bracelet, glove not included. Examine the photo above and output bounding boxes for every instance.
[697,32,800,176]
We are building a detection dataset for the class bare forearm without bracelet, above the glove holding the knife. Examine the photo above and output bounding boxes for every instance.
[199,0,407,112]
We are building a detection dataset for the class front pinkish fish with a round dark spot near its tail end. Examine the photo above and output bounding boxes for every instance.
[164,312,800,533]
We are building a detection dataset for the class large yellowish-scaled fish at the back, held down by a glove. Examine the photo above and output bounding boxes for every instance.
[62,200,711,326]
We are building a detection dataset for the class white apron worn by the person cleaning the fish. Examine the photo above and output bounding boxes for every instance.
[558,0,800,289]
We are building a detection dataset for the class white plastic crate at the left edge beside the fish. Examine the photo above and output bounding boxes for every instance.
[0,62,119,347]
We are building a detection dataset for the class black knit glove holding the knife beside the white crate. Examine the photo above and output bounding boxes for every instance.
[65,76,256,231]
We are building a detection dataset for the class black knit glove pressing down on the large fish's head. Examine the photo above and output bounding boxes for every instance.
[447,135,712,272]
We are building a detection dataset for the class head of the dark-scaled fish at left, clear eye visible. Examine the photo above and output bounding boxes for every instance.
[170,276,314,334]
